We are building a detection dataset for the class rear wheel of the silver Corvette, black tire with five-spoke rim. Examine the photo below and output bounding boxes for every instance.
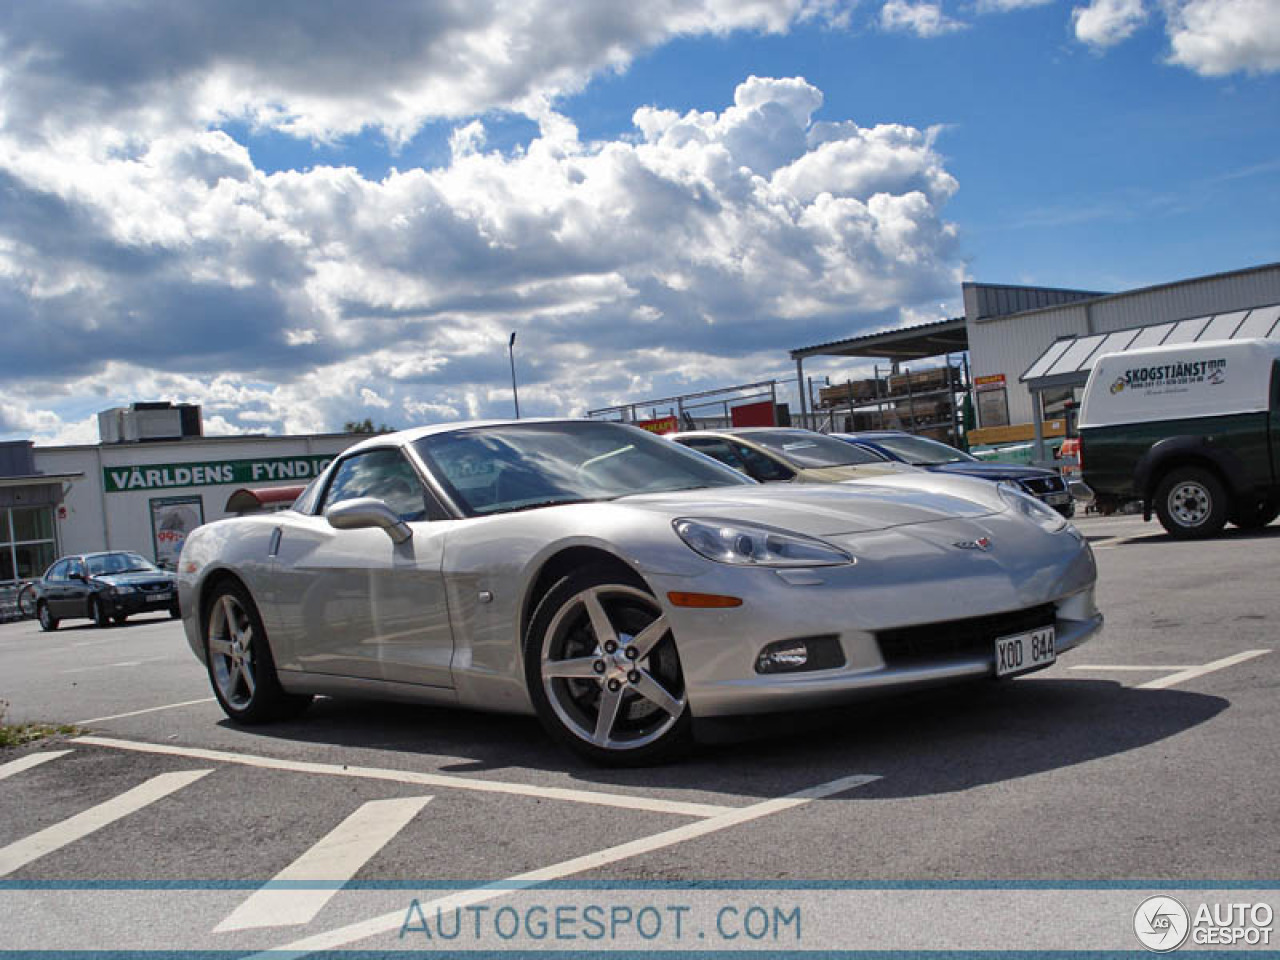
[201,580,311,724]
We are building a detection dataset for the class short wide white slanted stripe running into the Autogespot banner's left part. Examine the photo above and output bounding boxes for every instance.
[214,796,431,933]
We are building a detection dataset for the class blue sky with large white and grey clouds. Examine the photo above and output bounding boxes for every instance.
[0,0,1280,443]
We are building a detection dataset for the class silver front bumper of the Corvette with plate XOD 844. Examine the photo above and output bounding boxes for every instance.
[650,522,1102,718]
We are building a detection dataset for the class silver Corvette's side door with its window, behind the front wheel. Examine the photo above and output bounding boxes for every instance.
[269,448,453,686]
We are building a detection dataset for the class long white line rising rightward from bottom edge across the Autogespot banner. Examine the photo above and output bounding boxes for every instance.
[251,776,879,960]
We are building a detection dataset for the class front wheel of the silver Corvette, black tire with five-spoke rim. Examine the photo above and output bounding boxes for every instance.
[525,568,692,767]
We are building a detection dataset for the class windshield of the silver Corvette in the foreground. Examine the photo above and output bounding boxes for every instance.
[413,421,753,516]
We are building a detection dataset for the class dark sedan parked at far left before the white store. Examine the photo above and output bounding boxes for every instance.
[35,550,180,630]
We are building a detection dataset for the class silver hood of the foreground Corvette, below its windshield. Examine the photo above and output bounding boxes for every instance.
[614,471,1006,536]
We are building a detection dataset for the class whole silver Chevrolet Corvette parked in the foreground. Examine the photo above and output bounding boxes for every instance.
[179,420,1102,764]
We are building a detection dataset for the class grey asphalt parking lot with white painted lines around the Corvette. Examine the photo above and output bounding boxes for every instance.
[0,517,1280,948]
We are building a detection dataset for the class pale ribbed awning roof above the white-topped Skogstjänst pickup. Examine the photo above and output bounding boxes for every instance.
[1018,303,1280,390]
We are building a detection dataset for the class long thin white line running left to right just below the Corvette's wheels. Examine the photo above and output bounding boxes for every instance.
[80,736,737,817]
